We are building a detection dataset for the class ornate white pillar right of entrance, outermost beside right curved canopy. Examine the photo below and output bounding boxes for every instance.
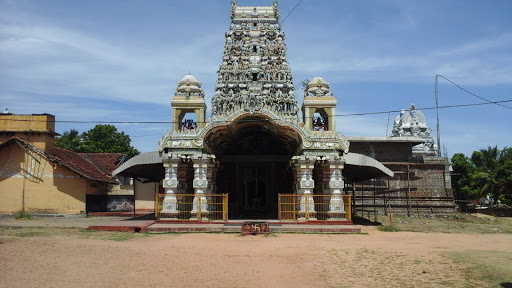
[327,157,345,221]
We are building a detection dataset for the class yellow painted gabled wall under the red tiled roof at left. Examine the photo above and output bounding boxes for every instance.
[0,143,107,214]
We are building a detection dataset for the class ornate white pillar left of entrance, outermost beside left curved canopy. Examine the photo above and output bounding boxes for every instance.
[164,159,179,219]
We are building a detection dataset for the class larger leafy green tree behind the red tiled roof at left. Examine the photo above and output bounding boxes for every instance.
[79,125,140,157]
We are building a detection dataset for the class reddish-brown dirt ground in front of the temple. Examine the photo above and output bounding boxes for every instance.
[0,219,512,287]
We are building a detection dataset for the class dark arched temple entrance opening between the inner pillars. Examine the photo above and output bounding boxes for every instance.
[204,113,301,219]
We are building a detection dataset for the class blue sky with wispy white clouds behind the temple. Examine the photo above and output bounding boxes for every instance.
[0,0,512,157]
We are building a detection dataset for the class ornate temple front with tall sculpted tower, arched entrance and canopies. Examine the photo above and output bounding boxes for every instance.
[114,2,454,221]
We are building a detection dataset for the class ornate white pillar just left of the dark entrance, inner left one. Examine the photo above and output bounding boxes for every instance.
[190,154,213,220]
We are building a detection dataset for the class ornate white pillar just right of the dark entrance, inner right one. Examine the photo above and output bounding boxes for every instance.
[297,155,316,221]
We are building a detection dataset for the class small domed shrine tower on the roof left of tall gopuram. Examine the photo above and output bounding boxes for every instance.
[171,74,206,132]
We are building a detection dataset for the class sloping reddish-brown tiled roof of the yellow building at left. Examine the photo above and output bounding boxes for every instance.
[0,137,122,183]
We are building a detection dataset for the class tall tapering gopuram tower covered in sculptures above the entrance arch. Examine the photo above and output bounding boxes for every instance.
[211,2,298,118]
